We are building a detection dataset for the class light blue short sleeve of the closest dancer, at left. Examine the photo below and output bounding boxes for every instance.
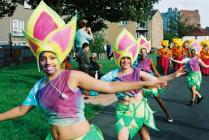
[22,79,44,106]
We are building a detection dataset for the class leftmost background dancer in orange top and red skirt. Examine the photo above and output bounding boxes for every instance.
[158,40,172,75]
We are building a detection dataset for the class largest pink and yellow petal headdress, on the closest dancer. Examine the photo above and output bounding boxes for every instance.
[23,1,77,68]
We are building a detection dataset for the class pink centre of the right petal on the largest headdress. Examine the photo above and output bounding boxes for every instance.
[49,28,72,52]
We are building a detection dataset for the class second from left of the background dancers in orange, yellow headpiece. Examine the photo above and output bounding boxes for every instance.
[171,38,184,71]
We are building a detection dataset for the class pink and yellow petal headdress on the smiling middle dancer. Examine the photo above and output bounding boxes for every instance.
[112,28,138,66]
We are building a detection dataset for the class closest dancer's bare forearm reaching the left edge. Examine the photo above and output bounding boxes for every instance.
[0,105,34,121]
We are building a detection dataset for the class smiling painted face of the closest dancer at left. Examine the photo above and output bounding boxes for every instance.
[39,52,60,75]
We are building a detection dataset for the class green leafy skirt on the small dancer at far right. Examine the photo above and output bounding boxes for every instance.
[186,72,202,90]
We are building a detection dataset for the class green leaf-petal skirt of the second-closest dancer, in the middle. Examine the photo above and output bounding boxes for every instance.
[115,98,158,139]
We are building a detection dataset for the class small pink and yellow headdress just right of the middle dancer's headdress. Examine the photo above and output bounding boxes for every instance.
[137,35,151,53]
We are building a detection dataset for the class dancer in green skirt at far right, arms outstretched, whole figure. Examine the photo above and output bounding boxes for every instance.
[171,42,209,106]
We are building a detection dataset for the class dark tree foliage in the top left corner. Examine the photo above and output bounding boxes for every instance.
[0,0,24,18]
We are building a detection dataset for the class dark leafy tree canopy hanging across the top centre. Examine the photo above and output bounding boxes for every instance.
[19,0,159,31]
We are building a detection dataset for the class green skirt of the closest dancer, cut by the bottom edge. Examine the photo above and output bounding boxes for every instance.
[45,125,104,140]
